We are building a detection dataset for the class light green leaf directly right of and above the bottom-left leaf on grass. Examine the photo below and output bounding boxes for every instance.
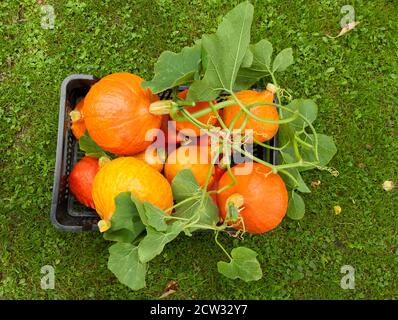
[138,221,183,262]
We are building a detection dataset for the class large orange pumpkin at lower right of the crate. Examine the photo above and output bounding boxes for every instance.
[217,163,288,234]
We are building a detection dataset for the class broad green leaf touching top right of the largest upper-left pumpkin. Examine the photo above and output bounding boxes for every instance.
[142,42,202,93]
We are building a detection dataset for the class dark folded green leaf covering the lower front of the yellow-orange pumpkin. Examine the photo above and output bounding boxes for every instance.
[103,192,145,242]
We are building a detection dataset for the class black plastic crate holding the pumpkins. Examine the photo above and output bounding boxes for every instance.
[51,74,277,232]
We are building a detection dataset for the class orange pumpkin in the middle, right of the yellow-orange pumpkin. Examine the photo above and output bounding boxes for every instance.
[164,145,215,187]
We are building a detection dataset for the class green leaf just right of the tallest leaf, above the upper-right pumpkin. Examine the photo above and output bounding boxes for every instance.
[234,39,273,90]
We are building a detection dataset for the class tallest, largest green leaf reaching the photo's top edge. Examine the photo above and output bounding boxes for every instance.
[187,1,254,101]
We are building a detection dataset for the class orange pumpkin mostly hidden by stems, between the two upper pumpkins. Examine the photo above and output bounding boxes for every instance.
[176,89,217,137]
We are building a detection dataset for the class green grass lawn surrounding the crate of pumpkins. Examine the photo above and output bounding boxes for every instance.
[0,0,398,299]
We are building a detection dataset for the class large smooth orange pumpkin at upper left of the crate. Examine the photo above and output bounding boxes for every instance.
[83,73,162,155]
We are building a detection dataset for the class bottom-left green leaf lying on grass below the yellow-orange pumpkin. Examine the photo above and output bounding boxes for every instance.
[108,243,147,290]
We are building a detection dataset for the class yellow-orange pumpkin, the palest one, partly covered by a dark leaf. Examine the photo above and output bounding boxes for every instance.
[93,157,173,220]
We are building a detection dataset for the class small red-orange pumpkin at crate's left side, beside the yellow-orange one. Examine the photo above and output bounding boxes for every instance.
[69,157,99,209]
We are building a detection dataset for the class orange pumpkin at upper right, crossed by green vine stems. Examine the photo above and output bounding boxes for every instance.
[223,90,279,142]
